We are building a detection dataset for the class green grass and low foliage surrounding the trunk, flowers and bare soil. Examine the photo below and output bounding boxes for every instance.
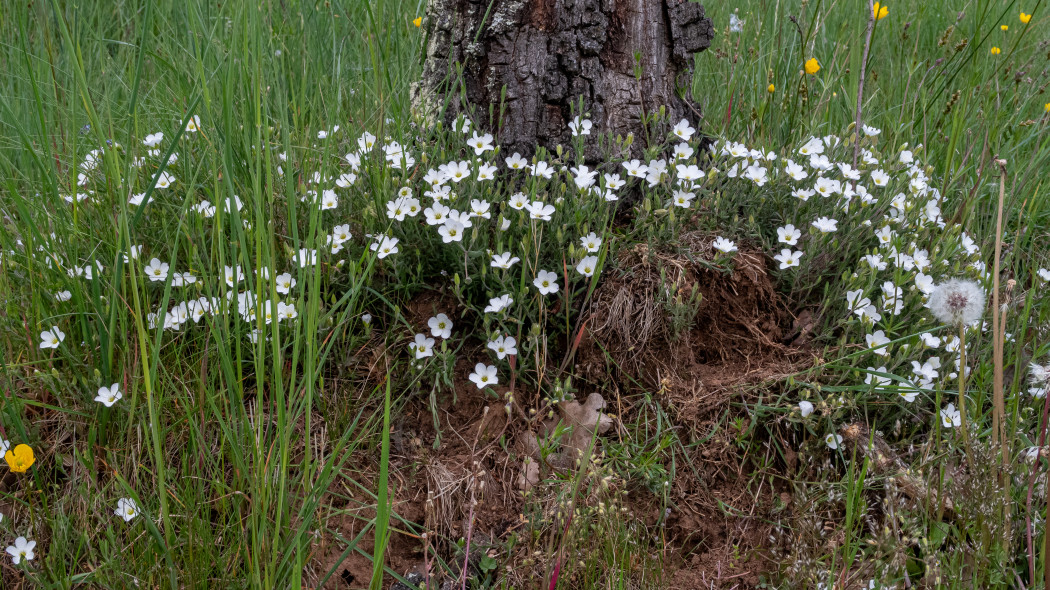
[0,0,1050,588]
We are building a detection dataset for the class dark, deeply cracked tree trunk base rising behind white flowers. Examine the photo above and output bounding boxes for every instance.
[415,0,714,154]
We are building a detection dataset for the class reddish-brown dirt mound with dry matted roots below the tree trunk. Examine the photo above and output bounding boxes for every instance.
[578,232,791,417]
